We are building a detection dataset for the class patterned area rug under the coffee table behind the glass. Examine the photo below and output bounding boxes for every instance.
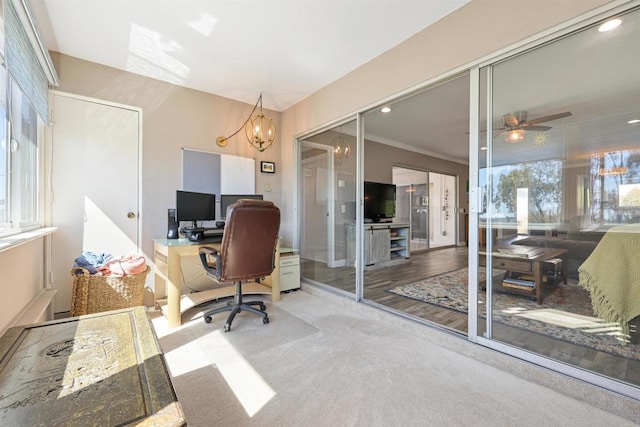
[387,267,640,360]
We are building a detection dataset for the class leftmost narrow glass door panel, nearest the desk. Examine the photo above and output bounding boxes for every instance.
[299,121,356,294]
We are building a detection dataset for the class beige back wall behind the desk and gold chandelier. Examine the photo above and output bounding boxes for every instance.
[51,52,282,257]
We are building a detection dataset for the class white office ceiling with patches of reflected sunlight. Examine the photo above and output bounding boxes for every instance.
[30,0,470,111]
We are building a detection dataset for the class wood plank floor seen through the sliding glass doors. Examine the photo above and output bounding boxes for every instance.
[301,247,640,386]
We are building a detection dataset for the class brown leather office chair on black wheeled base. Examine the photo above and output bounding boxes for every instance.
[200,199,280,332]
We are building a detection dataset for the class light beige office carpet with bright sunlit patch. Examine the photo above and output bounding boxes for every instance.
[152,289,638,426]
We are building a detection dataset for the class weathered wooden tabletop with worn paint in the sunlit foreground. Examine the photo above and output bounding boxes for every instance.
[0,307,186,427]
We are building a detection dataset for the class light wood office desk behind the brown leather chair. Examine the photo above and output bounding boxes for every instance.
[153,239,280,328]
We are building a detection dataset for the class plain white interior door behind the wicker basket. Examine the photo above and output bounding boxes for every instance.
[50,93,141,313]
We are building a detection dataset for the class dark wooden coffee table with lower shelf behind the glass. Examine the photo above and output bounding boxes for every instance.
[478,245,567,304]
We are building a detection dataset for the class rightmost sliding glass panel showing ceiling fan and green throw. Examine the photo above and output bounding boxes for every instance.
[477,5,640,392]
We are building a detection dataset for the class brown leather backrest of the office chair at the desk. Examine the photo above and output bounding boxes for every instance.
[217,199,280,282]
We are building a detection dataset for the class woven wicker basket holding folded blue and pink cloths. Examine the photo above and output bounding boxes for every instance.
[71,266,150,317]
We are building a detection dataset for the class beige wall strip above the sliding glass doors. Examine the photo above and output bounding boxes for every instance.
[281,0,610,242]
